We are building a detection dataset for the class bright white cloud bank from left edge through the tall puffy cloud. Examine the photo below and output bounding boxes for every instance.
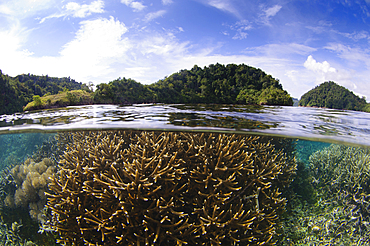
[0,17,132,82]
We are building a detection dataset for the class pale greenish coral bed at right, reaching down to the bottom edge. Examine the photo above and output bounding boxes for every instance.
[281,144,370,245]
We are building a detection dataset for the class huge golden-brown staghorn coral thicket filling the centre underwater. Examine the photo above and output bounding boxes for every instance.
[47,131,295,245]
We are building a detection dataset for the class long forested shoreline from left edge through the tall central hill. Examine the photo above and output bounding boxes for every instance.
[0,63,293,114]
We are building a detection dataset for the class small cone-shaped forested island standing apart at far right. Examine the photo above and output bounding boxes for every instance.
[299,81,368,111]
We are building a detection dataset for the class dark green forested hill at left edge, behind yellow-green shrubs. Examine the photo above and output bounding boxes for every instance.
[0,70,90,115]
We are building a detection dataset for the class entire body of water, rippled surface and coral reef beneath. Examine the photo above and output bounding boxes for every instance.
[0,105,370,245]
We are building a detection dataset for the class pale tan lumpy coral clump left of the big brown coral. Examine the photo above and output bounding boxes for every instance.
[4,158,55,223]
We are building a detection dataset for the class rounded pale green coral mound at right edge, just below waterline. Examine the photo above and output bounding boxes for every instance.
[310,145,370,213]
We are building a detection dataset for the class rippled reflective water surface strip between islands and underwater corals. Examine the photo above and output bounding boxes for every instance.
[0,104,370,146]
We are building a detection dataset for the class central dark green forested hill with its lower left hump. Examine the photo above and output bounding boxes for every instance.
[94,63,293,105]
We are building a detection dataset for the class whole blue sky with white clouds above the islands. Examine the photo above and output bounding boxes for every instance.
[0,0,370,101]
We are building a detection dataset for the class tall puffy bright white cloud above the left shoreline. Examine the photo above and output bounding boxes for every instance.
[60,17,131,77]
